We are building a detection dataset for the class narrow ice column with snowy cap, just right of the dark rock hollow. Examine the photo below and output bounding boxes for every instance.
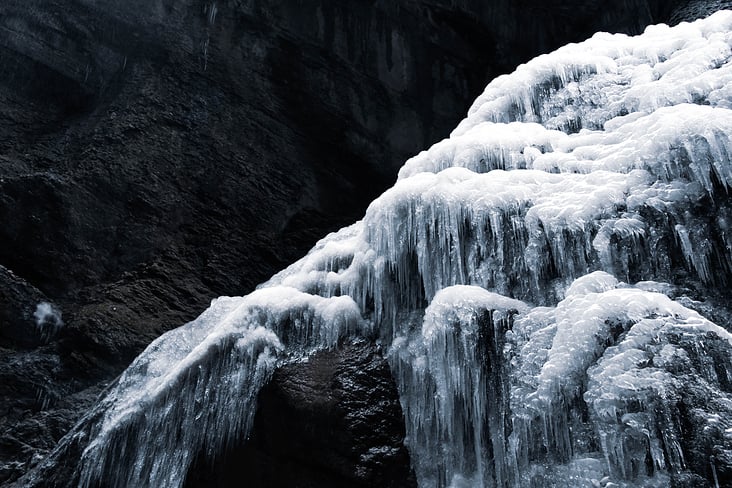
[390,286,527,487]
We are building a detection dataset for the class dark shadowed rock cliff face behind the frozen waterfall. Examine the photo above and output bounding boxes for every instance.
[0,0,726,483]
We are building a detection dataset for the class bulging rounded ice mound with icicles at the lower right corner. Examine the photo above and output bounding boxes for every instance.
[511,273,732,486]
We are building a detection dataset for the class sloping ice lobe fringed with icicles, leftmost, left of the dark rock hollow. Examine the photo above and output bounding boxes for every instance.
[80,287,364,488]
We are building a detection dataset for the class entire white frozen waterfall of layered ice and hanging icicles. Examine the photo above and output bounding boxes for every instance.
[68,12,732,487]
